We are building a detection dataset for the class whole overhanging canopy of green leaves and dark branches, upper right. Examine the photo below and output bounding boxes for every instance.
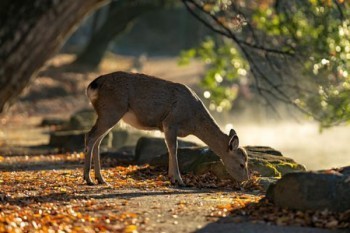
[180,0,350,127]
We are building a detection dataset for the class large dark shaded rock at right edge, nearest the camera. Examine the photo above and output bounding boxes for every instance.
[266,167,350,212]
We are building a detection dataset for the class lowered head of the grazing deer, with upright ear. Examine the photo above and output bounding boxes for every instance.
[221,129,249,182]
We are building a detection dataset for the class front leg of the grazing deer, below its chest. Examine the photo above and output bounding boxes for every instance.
[164,126,185,186]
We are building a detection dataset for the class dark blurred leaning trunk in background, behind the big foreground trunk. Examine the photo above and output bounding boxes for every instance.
[73,0,163,69]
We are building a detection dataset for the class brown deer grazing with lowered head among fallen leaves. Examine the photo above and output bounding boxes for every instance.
[84,71,249,186]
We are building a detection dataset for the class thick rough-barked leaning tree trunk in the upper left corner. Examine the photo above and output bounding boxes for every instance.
[0,0,108,113]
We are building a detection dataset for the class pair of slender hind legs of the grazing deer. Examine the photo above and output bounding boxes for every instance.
[84,111,126,185]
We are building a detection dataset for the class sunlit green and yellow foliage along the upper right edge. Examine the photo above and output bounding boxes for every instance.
[268,1,350,128]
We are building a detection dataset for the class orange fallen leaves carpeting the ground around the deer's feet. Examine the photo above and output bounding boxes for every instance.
[0,153,350,233]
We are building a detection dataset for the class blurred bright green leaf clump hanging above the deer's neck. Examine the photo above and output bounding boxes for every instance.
[179,37,249,112]
